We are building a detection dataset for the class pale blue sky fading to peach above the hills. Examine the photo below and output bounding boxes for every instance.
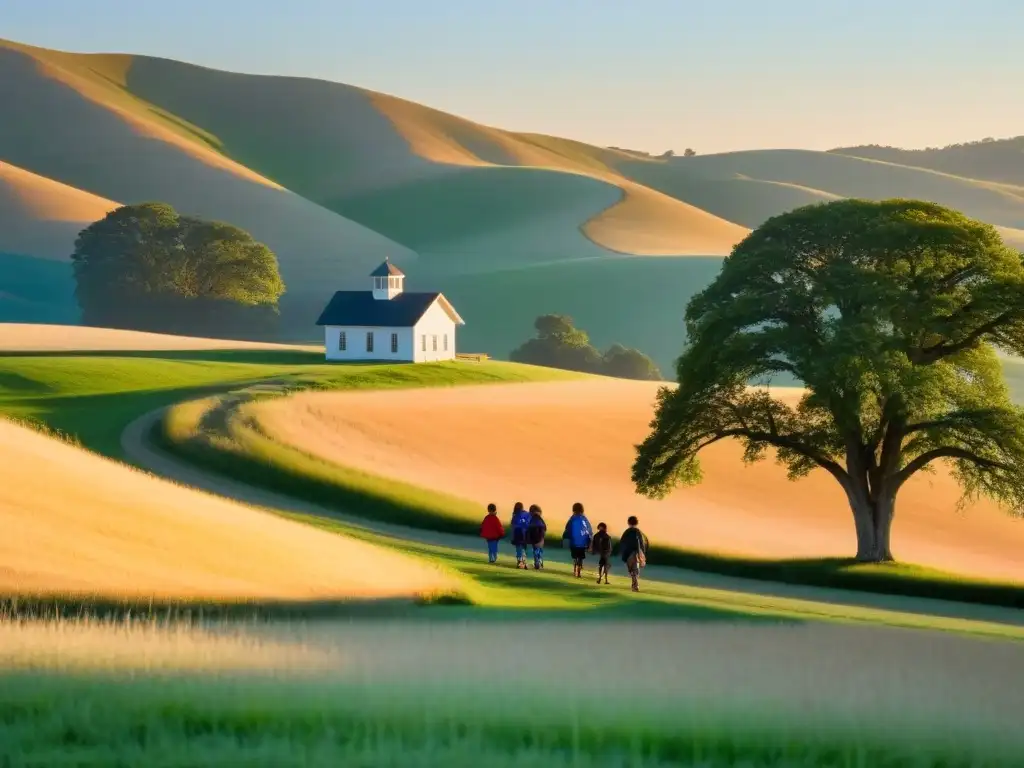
[0,0,1024,154]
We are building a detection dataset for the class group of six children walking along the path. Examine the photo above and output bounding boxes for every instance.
[480,502,649,592]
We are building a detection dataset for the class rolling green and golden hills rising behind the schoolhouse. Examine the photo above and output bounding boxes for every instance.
[6,41,1024,369]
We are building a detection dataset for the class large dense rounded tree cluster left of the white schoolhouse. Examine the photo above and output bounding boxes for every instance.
[72,203,285,338]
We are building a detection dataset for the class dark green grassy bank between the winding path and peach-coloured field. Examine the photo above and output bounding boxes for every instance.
[155,385,1024,607]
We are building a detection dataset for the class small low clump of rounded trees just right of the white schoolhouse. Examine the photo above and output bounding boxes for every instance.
[510,314,662,381]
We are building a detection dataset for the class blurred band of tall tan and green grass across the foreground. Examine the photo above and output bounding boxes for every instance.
[6,622,1024,768]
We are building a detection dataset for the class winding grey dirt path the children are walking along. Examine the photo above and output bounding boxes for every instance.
[121,409,1024,626]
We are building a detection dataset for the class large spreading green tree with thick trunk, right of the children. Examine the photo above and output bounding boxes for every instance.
[633,200,1024,561]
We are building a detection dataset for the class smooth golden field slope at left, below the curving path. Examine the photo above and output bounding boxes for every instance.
[0,419,452,601]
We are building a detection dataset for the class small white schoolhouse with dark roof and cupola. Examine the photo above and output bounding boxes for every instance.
[316,261,466,362]
